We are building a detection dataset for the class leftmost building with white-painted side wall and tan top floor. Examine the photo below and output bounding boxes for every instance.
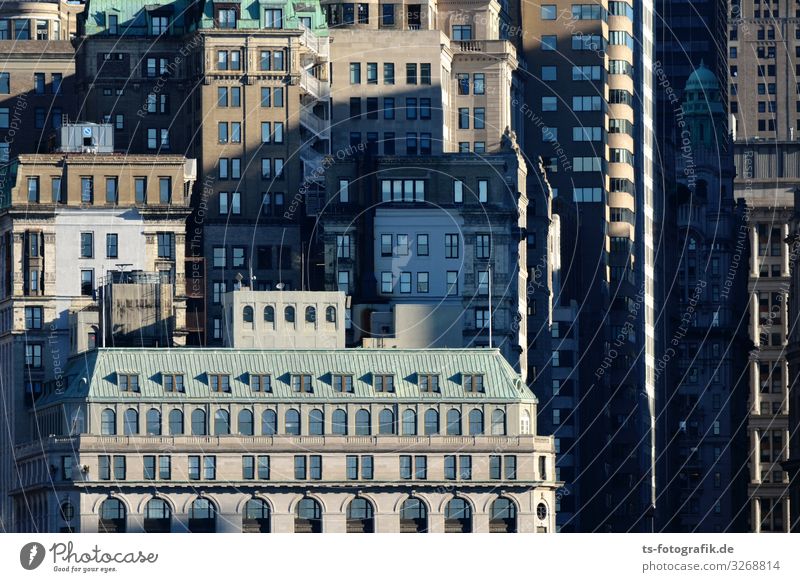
[0,124,194,523]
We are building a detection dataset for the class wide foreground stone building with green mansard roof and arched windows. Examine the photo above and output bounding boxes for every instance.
[14,348,557,533]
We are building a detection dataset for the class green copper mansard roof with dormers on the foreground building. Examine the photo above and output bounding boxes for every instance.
[40,348,535,405]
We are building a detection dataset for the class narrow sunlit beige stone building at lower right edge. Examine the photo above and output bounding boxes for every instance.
[735,141,800,532]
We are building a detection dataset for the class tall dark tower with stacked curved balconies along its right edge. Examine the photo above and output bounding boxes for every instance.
[517,1,661,531]
